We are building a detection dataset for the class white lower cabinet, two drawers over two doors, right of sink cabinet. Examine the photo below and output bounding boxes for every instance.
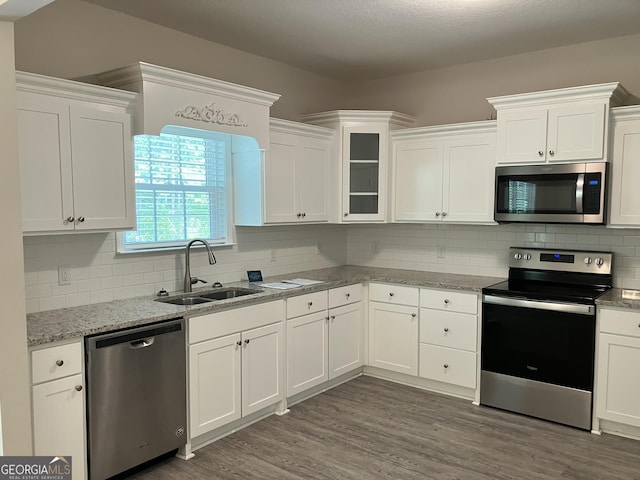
[287,284,364,396]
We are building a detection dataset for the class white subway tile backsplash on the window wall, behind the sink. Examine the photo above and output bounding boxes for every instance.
[24,225,347,312]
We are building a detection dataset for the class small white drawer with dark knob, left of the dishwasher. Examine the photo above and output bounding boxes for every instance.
[31,342,82,384]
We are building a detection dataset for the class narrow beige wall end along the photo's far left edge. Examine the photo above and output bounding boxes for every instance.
[0,21,32,455]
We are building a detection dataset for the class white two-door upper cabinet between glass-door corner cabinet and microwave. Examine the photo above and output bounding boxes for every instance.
[391,121,496,223]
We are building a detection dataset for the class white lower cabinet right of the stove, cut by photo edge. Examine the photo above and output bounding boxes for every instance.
[595,309,640,427]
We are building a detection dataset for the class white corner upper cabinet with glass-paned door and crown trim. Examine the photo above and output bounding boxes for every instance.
[302,110,414,222]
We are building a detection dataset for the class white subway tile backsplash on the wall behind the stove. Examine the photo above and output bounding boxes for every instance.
[347,224,640,289]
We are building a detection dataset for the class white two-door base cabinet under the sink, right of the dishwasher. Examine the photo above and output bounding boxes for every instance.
[189,301,284,438]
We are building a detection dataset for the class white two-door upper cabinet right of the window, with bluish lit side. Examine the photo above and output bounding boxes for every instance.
[234,118,333,225]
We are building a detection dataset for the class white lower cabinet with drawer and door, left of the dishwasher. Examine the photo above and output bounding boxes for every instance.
[31,342,86,480]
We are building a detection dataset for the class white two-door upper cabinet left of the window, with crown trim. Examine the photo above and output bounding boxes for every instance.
[17,73,136,234]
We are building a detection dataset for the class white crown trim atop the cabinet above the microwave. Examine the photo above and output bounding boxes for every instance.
[487,82,629,110]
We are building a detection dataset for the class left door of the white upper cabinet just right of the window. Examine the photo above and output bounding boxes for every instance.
[264,132,300,223]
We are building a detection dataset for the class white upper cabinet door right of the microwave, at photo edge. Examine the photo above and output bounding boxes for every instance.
[609,121,640,226]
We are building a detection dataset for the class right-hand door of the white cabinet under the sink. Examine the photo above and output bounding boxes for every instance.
[242,323,284,416]
